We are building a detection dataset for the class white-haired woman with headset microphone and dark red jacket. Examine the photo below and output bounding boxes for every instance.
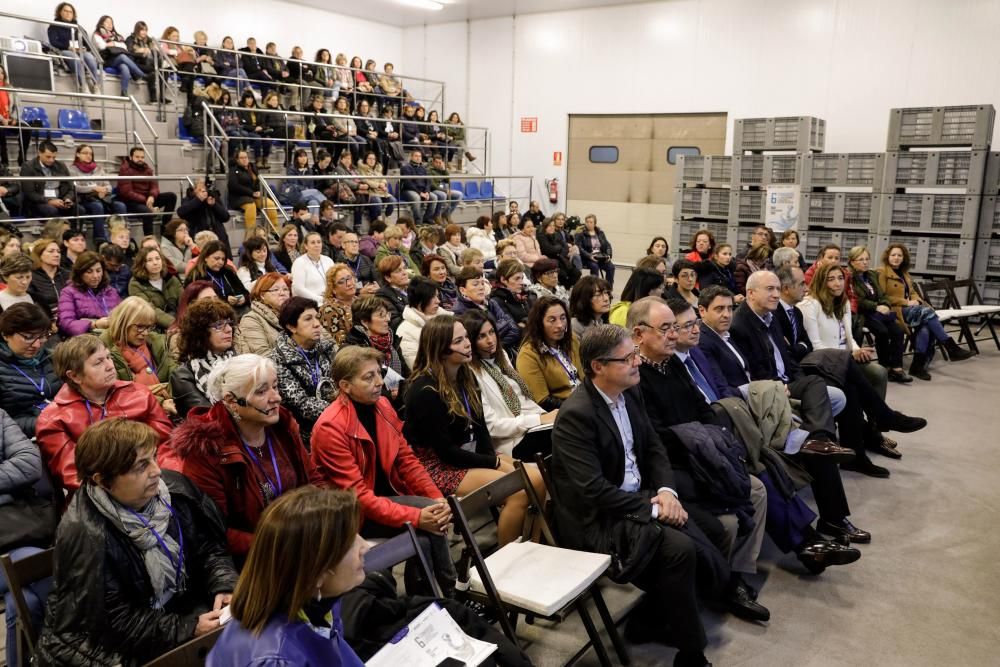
[164,354,322,563]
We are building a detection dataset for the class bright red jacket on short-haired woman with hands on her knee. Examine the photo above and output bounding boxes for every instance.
[311,395,444,528]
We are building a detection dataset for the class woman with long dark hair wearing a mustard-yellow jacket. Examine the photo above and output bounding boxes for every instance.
[517,296,583,410]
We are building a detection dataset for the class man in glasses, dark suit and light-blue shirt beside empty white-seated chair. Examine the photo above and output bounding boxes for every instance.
[551,325,708,667]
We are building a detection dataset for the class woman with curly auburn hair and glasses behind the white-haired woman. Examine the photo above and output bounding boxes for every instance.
[170,299,236,418]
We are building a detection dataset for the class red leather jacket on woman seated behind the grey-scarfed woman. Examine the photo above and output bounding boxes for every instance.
[35,380,174,492]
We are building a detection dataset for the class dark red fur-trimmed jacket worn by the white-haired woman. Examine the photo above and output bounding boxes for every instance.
[157,402,324,556]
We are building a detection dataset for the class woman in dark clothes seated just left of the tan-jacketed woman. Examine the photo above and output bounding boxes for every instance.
[848,246,923,384]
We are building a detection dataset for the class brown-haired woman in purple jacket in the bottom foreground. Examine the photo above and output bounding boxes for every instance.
[207,486,368,667]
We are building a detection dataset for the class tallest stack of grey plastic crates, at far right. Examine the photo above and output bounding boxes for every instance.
[872,105,1000,290]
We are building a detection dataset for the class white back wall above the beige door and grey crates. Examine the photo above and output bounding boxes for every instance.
[403,0,1000,206]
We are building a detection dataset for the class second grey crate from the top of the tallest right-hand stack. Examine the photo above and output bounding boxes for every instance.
[883,151,987,195]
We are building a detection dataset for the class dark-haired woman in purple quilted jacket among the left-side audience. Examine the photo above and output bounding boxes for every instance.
[59,251,122,338]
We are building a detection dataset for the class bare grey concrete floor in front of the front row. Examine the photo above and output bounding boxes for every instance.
[521,342,1000,667]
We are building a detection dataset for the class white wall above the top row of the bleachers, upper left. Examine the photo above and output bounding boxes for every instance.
[0,0,407,73]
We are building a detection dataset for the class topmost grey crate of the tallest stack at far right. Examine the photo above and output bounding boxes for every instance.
[886,104,996,151]
